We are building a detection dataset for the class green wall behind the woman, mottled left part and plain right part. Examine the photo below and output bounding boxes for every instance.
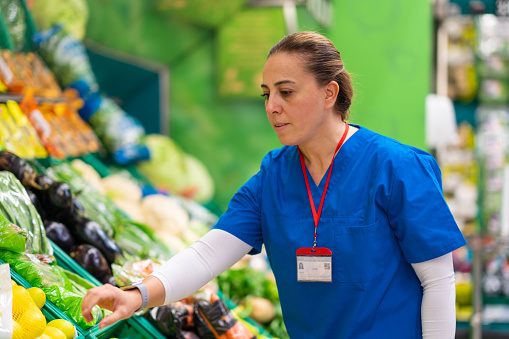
[87,0,431,210]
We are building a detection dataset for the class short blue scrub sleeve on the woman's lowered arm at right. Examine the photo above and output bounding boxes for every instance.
[387,151,466,263]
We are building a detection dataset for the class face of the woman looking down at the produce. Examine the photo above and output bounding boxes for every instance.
[261,53,333,146]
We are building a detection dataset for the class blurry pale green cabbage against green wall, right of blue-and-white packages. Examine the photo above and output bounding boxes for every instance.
[137,134,214,203]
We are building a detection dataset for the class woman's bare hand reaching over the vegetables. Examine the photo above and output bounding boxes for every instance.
[81,284,142,329]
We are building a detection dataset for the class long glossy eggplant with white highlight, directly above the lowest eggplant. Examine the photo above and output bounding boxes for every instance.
[67,215,125,264]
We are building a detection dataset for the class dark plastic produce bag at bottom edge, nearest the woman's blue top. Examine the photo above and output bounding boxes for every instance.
[194,299,255,339]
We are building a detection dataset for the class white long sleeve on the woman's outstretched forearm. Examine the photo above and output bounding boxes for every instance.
[151,229,252,305]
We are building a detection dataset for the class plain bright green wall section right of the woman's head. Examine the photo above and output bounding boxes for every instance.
[329,0,432,148]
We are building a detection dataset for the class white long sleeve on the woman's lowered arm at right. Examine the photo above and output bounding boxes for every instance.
[412,253,456,339]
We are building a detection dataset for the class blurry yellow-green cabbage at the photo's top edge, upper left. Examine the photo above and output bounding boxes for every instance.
[32,0,88,40]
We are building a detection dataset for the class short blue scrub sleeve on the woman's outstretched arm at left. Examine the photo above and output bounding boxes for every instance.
[214,155,270,254]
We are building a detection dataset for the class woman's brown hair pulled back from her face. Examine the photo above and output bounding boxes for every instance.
[267,32,353,120]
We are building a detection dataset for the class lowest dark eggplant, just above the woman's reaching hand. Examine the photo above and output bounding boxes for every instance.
[69,244,116,285]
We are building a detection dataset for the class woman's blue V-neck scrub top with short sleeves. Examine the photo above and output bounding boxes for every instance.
[215,126,466,339]
